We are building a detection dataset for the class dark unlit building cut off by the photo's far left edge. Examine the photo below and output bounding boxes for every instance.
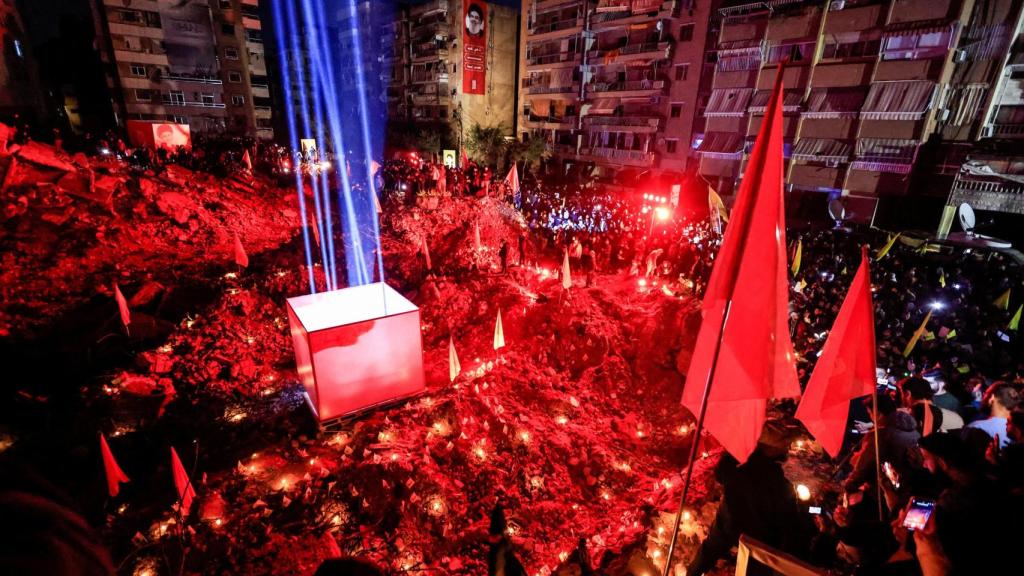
[0,0,45,121]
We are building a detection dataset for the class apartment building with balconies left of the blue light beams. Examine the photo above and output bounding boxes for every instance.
[92,0,273,138]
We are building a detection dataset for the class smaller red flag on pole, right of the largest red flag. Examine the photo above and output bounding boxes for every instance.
[797,247,876,457]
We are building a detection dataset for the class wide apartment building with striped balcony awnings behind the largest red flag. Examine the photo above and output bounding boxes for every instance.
[693,0,1020,220]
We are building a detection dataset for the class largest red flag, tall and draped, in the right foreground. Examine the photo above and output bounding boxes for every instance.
[683,68,800,462]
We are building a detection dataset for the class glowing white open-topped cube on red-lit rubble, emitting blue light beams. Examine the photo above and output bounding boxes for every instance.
[288,283,426,422]
